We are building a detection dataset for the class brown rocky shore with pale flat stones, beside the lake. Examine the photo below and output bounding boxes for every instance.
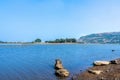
[71,59,120,80]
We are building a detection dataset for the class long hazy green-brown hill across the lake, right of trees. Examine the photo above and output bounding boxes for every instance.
[78,32,120,44]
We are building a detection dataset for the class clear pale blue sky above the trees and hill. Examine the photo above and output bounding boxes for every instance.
[0,0,120,41]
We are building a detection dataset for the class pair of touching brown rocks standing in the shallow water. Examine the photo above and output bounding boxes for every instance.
[55,59,70,77]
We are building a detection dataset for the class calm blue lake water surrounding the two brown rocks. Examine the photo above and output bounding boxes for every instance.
[0,44,120,80]
